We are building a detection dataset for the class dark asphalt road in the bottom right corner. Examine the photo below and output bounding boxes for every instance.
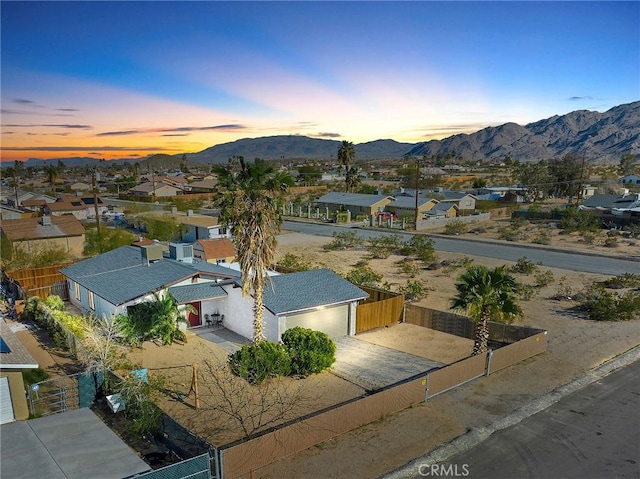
[436,361,640,479]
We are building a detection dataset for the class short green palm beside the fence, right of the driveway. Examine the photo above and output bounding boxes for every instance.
[451,266,522,356]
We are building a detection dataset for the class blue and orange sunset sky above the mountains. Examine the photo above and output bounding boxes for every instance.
[0,0,640,161]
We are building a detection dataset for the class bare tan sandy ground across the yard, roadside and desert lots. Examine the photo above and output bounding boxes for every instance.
[10,225,640,479]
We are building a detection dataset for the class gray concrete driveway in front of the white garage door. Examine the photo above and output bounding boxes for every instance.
[331,336,444,390]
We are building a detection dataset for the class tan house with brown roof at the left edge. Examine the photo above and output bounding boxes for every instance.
[0,215,85,256]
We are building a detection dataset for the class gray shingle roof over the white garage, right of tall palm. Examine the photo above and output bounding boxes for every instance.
[264,269,369,314]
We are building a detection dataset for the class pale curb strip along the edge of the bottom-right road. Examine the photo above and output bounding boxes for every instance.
[381,346,640,479]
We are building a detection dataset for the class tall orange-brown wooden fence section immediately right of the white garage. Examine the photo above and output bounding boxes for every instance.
[356,286,404,334]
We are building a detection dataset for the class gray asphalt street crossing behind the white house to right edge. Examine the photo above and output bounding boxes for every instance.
[283,221,640,276]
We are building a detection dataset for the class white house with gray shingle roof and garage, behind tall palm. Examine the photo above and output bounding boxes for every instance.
[60,245,368,341]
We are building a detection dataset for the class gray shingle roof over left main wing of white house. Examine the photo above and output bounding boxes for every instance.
[60,246,197,305]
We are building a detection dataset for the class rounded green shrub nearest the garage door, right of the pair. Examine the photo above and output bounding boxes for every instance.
[282,327,336,376]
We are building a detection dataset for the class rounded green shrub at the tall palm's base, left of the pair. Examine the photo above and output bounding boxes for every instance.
[228,341,291,384]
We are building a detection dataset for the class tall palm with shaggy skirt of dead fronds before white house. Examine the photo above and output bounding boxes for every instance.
[214,156,295,343]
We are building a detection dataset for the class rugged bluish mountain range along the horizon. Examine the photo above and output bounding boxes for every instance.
[15,101,640,166]
